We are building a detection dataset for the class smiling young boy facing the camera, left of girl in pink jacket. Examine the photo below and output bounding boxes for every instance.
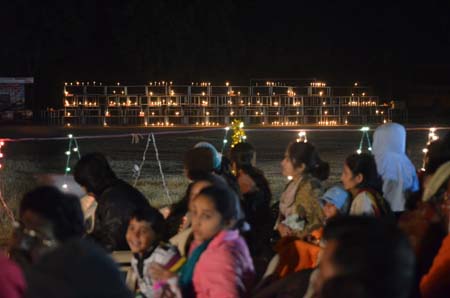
[126,207,182,298]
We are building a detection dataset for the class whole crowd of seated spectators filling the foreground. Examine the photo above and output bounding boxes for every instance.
[0,123,450,298]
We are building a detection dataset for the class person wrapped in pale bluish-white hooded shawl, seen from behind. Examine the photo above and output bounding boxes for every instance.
[372,123,419,213]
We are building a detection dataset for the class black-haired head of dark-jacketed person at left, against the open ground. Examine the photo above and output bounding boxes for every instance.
[73,153,117,197]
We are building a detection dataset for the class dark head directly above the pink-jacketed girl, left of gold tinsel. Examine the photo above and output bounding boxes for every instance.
[184,147,214,180]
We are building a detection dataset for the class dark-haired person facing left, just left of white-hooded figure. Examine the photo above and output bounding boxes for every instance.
[341,153,391,216]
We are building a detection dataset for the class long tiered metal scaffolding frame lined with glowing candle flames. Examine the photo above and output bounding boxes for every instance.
[55,82,392,126]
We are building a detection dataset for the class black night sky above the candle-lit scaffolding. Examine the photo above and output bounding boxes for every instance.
[0,0,450,107]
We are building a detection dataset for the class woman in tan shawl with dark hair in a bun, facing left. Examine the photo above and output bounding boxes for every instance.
[275,142,330,238]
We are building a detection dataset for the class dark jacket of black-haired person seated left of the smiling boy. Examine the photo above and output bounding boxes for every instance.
[91,179,150,251]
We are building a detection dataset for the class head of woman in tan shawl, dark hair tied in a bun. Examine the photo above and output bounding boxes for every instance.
[281,142,330,180]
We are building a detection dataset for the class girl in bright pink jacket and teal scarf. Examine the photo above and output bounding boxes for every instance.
[150,186,254,298]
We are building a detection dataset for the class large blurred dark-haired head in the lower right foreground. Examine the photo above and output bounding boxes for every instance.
[315,216,415,297]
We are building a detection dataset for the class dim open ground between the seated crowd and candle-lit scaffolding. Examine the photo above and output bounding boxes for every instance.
[0,126,448,246]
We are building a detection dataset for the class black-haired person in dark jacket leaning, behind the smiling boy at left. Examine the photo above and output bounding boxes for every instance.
[74,153,150,251]
